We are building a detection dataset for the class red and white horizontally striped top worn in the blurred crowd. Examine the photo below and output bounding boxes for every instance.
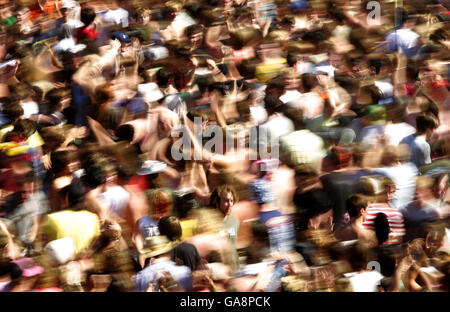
[363,203,406,244]
